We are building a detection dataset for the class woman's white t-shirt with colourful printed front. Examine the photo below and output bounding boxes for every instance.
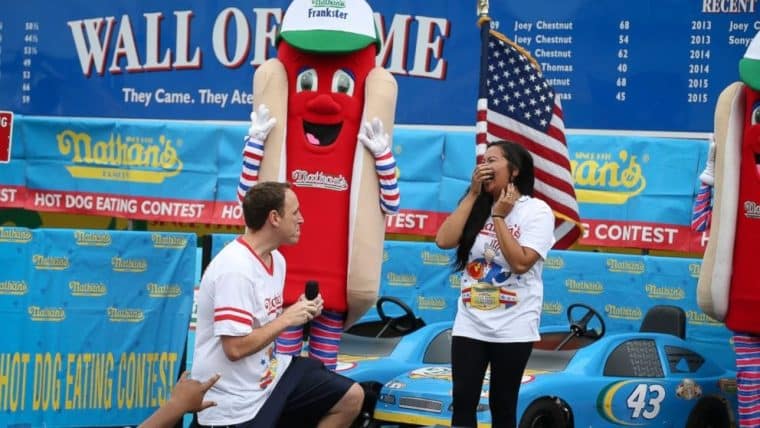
[452,196,555,342]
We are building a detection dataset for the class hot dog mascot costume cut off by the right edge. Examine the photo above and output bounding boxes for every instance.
[697,33,760,427]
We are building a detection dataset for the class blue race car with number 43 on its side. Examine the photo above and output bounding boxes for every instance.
[373,304,737,428]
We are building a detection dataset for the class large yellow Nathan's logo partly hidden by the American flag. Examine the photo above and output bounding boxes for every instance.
[570,150,649,205]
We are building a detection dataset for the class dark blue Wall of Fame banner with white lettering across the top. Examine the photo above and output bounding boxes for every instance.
[0,0,760,132]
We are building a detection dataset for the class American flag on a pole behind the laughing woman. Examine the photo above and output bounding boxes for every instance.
[476,22,581,249]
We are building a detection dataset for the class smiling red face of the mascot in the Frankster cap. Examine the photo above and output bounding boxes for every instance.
[277,40,375,152]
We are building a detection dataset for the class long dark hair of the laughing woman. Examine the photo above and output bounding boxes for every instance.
[454,140,536,271]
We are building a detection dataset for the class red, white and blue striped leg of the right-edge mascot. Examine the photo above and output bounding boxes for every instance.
[734,334,760,427]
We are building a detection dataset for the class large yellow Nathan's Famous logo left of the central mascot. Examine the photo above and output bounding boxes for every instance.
[56,129,182,183]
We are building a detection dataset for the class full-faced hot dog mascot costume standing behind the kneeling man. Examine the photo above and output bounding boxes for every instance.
[238,0,399,368]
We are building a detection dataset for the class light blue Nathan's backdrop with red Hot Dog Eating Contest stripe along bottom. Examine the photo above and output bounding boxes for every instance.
[0,116,708,255]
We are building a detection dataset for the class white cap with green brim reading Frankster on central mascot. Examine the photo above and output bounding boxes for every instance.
[279,0,380,53]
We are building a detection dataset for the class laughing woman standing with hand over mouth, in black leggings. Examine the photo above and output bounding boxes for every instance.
[435,141,554,428]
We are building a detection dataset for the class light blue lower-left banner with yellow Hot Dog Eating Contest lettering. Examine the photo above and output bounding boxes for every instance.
[0,228,196,426]
